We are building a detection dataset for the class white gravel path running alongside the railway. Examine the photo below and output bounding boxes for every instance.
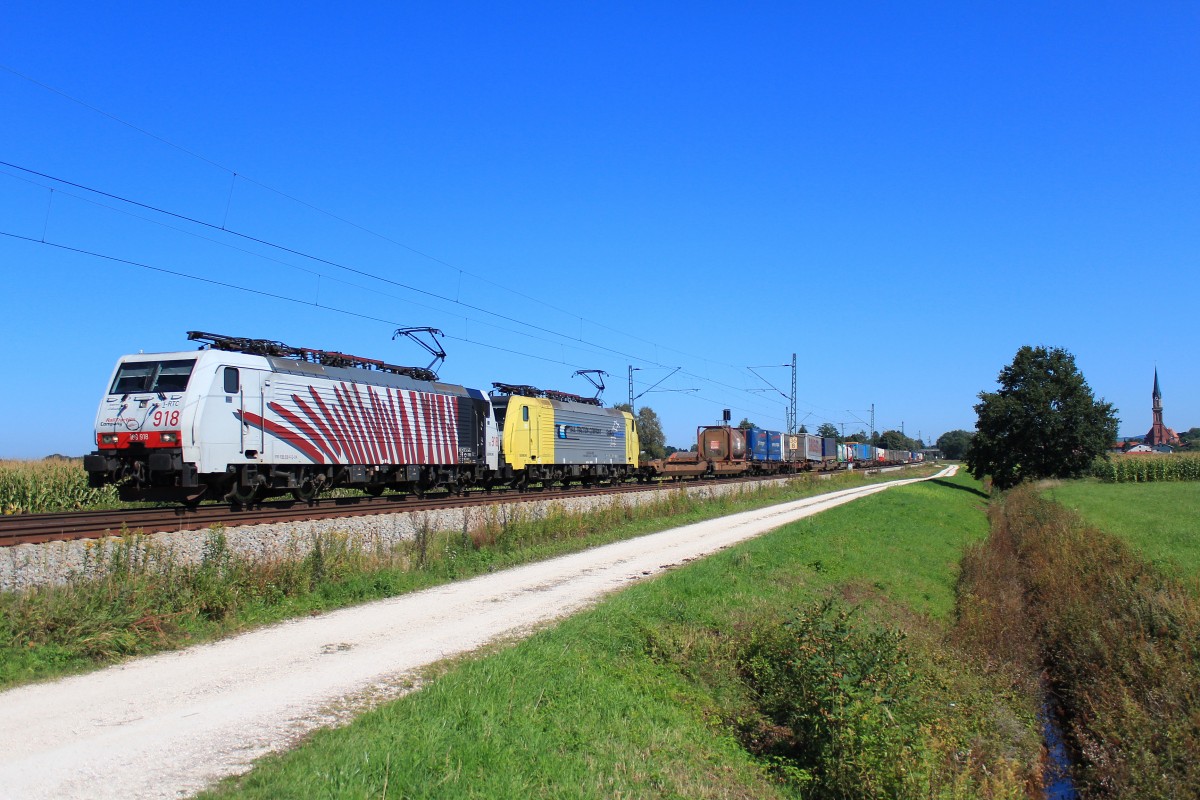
[0,467,956,799]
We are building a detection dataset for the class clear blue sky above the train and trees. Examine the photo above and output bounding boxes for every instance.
[0,2,1200,458]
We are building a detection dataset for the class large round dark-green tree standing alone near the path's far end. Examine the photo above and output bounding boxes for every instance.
[966,345,1117,489]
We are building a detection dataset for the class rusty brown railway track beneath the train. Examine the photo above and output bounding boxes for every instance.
[0,475,806,547]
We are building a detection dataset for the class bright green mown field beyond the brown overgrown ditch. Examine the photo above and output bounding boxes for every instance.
[1045,480,1200,578]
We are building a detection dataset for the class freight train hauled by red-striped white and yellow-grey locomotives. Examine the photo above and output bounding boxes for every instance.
[84,331,917,505]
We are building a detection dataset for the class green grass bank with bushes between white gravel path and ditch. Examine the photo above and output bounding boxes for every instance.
[208,477,1039,798]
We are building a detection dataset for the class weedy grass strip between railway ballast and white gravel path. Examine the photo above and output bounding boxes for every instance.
[0,468,932,687]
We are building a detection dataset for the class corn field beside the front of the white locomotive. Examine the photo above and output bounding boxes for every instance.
[0,458,121,515]
